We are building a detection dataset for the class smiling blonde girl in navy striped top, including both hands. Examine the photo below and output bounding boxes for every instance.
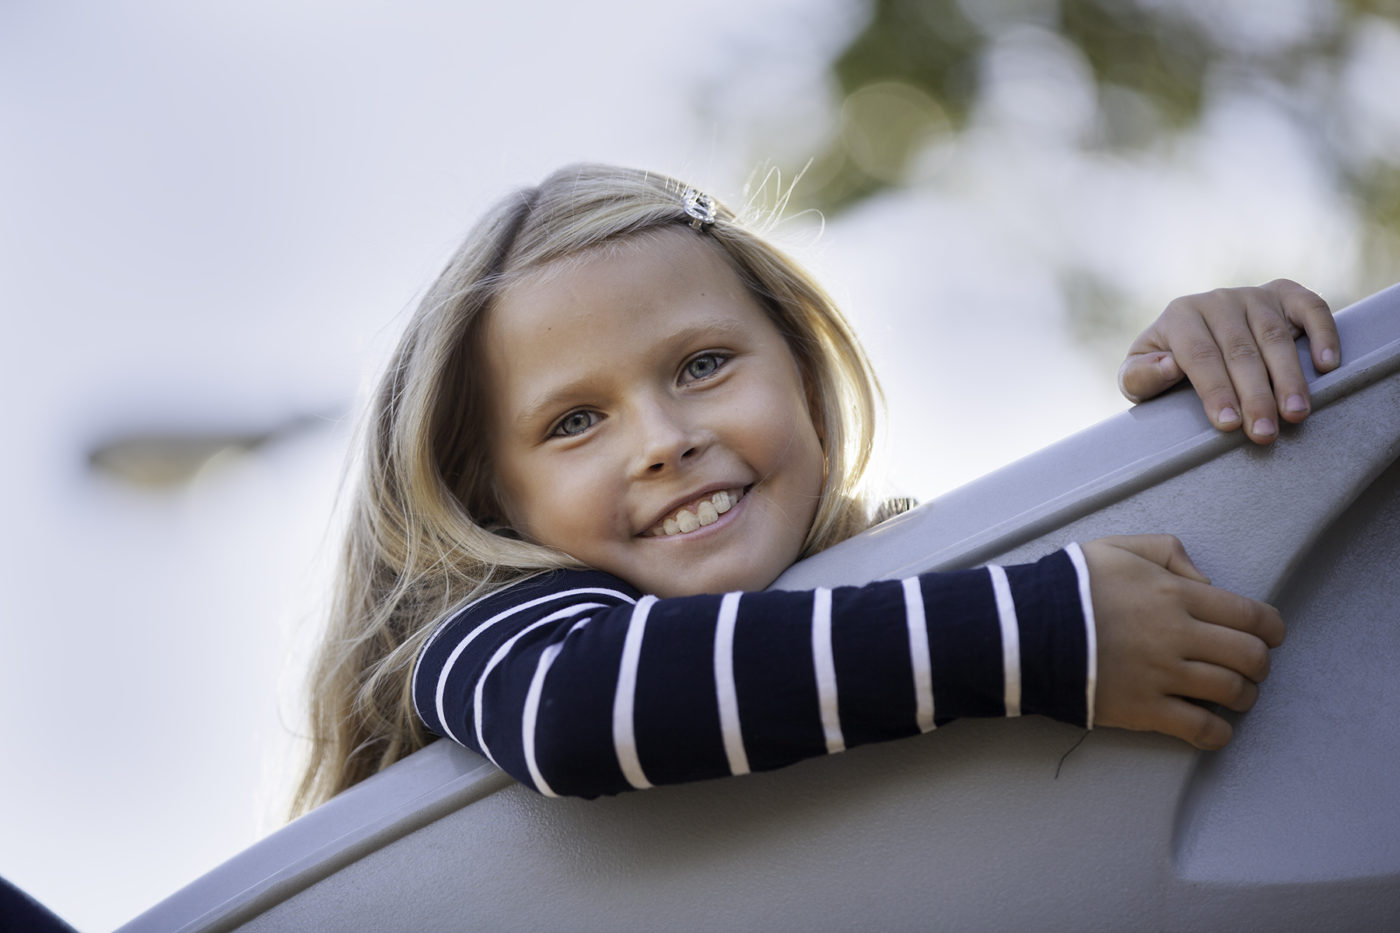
[289,165,1338,808]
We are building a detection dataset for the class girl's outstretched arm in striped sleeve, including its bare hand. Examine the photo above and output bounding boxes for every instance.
[413,537,1282,797]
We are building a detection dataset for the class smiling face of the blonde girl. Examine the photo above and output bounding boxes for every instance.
[483,227,825,597]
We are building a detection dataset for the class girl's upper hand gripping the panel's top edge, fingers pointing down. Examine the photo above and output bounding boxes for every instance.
[1119,279,1341,444]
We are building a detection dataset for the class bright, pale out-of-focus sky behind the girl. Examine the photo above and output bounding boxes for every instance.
[0,0,1400,930]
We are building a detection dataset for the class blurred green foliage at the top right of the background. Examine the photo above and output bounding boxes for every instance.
[798,0,1400,295]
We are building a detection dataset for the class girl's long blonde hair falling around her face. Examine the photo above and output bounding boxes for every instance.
[293,165,879,813]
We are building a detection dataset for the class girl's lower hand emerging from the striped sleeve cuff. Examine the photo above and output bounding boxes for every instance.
[1084,535,1284,748]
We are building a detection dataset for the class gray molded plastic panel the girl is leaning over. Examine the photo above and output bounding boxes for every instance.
[122,282,1400,933]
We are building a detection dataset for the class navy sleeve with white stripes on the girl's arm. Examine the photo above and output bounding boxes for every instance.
[413,545,1096,797]
